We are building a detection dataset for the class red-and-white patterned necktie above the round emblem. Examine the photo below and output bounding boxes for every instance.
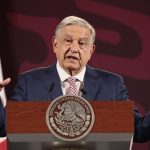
[66,77,78,95]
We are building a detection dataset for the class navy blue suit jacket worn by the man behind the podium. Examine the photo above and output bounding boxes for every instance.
[0,64,150,142]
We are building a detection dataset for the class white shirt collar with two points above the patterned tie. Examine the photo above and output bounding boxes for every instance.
[56,61,86,82]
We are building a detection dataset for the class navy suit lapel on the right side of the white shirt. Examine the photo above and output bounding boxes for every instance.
[82,66,101,100]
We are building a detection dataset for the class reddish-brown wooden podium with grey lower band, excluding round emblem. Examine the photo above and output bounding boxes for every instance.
[6,101,134,150]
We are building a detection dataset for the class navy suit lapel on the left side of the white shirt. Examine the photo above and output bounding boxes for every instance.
[44,64,62,100]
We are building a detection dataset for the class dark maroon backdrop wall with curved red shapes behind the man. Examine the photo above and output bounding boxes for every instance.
[0,0,150,150]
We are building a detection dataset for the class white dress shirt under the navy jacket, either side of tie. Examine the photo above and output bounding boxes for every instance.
[56,62,86,96]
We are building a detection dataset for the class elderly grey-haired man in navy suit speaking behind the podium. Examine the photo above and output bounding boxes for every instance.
[1,16,150,142]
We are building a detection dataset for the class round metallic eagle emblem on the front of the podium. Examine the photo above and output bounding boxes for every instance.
[46,95,95,141]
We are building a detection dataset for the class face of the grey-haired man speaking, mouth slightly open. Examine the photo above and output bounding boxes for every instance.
[53,25,95,74]
